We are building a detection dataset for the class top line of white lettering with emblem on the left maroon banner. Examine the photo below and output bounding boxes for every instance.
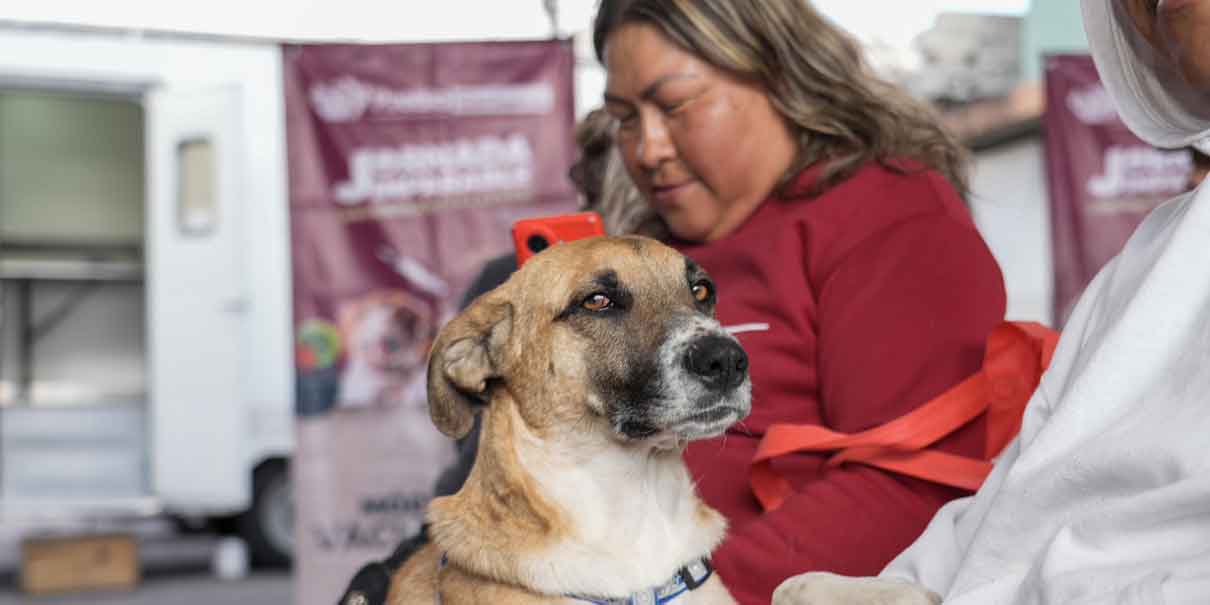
[309,76,554,122]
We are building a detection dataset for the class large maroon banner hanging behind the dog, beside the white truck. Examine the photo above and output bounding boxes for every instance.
[283,41,575,605]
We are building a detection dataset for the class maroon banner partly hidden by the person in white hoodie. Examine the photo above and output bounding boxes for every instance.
[1043,54,1192,327]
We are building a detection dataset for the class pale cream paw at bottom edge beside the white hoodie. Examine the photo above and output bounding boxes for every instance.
[773,571,941,605]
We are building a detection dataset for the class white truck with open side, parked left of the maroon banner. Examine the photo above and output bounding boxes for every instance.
[0,23,294,561]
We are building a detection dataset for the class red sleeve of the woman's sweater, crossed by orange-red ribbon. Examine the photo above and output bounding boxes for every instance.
[715,213,1004,604]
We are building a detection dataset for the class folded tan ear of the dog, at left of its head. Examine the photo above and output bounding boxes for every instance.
[428,296,513,438]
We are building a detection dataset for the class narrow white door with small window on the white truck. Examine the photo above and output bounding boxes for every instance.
[145,87,250,513]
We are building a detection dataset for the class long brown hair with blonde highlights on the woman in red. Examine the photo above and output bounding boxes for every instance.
[593,0,968,196]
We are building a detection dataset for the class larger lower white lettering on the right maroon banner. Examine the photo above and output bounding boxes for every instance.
[1087,145,1193,198]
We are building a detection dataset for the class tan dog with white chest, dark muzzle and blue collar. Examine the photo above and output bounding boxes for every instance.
[387,237,750,605]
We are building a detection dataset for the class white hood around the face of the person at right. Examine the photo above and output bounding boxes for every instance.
[1083,0,1210,152]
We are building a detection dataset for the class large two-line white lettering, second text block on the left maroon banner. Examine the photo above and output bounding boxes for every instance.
[334,134,534,206]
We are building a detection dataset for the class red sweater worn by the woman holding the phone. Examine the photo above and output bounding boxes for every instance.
[676,165,1004,605]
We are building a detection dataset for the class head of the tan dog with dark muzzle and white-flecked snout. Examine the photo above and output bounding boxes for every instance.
[428,237,751,446]
